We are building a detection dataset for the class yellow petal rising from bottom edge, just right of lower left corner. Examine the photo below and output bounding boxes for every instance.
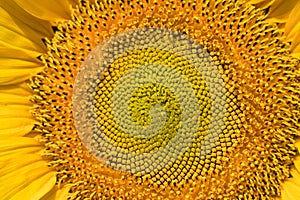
[11,172,56,200]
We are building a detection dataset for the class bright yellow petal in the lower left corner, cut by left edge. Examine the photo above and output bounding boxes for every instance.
[0,161,51,199]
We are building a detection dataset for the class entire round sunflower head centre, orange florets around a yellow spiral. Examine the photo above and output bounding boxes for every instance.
[31,0,300,199]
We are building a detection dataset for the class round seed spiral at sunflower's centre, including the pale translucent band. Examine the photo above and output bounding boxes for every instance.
[73,28,225,178]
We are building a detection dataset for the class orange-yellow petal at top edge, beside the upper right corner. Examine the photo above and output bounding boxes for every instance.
[268,0,299,22]
